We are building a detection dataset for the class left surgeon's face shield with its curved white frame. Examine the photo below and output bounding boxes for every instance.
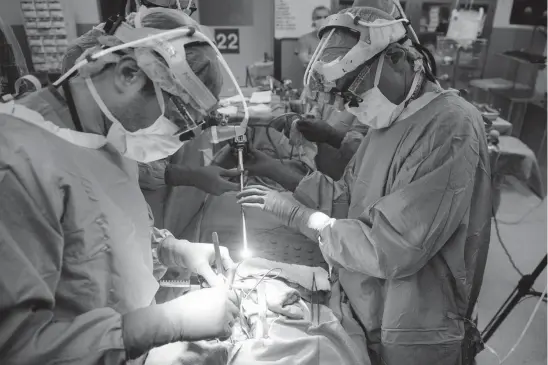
[54,8,249,159]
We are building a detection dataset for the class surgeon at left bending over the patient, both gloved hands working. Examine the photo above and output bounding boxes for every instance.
[0,7,242,365]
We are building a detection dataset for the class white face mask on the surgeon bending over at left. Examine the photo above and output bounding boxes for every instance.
[85,78,188,163]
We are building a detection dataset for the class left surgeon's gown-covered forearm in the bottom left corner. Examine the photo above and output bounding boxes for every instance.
[0,302,131,365]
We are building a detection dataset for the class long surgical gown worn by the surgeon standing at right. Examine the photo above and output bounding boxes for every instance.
[294,92,491,365]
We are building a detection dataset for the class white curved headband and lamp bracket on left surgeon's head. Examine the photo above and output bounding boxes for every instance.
[53,23,249,141]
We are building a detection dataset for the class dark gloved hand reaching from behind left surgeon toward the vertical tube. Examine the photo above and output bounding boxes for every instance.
[166,165,240,195]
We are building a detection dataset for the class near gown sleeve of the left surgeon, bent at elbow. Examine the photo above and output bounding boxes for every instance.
[0,166,126,365]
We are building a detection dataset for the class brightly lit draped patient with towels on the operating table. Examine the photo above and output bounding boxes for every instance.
[147,258,370,365]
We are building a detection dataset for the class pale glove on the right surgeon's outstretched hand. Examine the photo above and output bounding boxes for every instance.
[236,185,333,241]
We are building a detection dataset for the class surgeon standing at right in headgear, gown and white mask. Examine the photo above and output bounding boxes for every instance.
[231,1,491,365]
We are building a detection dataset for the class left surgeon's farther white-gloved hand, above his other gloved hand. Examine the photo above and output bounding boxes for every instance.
[157,237,235,287]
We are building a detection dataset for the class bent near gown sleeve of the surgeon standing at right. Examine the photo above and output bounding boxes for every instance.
[319,113,480,279]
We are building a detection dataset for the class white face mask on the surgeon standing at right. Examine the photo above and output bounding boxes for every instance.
[345,53,421,129]
